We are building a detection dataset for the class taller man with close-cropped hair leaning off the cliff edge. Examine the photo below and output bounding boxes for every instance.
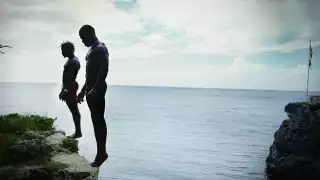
[78,25,109,167]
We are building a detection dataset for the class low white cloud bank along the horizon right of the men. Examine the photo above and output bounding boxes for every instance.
[109,56,320,90]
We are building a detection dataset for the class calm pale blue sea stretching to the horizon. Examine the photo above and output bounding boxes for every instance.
[0,83,312,180]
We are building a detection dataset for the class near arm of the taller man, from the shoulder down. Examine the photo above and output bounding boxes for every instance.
[92,46,109,89]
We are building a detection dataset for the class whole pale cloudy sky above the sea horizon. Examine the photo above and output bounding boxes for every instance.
[0,0,320,91]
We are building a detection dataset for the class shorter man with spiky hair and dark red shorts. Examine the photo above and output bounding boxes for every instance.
[59,41,82,139]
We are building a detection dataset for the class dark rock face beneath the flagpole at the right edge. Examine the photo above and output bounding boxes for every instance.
[266,103,320,180]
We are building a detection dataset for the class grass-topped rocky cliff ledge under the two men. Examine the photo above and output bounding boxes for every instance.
[0,114,98,180]
